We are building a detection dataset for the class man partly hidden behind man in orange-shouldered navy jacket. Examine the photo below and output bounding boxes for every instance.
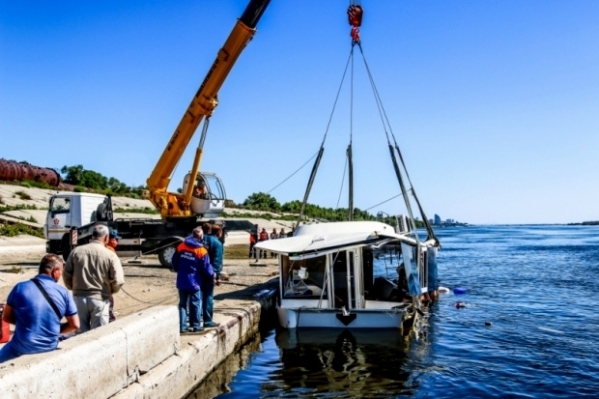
[201,223,223,328]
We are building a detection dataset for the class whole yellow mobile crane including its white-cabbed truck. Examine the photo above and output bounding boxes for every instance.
[55,0,270,267]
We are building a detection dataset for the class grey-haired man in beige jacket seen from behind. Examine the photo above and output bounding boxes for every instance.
[62,224,125,333]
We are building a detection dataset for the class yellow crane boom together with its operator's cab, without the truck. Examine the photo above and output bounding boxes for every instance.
[147,0,270,219]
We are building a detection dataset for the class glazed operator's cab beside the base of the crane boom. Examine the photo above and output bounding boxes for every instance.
[183,172,226,217]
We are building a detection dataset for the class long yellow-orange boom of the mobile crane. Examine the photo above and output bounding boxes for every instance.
[147,0,270,218]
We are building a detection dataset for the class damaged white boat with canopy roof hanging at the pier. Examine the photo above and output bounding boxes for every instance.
[256,221,438,331]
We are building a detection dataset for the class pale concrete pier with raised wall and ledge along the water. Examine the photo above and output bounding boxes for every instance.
[0,289,275,399]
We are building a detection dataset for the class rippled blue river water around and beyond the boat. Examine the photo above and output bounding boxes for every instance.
[190,226,599,398]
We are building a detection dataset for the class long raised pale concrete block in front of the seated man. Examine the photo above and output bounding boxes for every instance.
[0,306,180,399]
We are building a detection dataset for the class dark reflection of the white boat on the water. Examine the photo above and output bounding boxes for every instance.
[276,330,426,397]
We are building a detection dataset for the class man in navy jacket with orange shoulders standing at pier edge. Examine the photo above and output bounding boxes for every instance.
[173,227,215,333]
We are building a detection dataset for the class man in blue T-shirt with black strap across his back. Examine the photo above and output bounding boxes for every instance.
[0,254,79,363]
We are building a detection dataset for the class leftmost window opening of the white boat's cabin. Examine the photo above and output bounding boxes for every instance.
[282,255,327,299]
